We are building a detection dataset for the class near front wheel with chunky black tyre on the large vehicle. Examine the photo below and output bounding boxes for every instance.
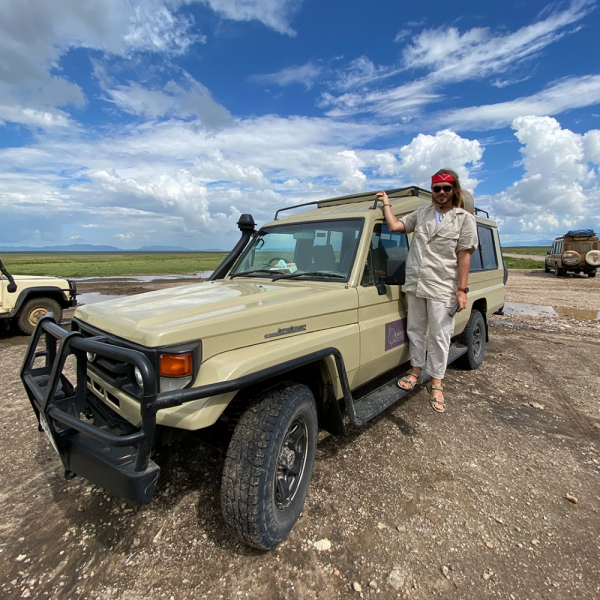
[221,382,318,550]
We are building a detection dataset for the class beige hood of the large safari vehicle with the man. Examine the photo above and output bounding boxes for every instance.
[75,278,358,358]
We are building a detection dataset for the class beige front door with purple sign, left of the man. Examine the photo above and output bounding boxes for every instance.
[357,223,408,385]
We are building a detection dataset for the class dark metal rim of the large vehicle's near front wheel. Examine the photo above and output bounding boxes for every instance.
[274,417,308,510]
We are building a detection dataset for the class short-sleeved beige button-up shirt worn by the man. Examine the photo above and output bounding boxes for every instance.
[400,204,479,306]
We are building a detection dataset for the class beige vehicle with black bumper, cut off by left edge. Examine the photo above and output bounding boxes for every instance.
[0,261,77,335]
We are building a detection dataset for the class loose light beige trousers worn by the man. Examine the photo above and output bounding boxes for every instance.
[405,292,454,379]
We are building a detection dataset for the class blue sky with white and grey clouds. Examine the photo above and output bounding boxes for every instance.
[0,0,600,249]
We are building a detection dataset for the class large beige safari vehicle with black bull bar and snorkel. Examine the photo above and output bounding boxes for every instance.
[21,187,505,549]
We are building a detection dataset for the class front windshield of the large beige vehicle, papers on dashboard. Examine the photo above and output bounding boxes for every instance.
[230,219,363,281]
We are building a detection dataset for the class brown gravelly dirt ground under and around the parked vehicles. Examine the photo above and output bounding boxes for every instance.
[0,271,600,600]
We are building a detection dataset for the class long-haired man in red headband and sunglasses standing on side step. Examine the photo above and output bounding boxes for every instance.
[377,169,478,412]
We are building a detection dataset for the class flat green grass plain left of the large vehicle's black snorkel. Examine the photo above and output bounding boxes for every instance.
[0,252,227,277]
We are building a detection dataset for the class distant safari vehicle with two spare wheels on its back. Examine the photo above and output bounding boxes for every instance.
[544,229,600,277]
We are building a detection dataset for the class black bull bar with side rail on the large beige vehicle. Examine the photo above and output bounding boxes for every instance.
[21,313,356,502]
